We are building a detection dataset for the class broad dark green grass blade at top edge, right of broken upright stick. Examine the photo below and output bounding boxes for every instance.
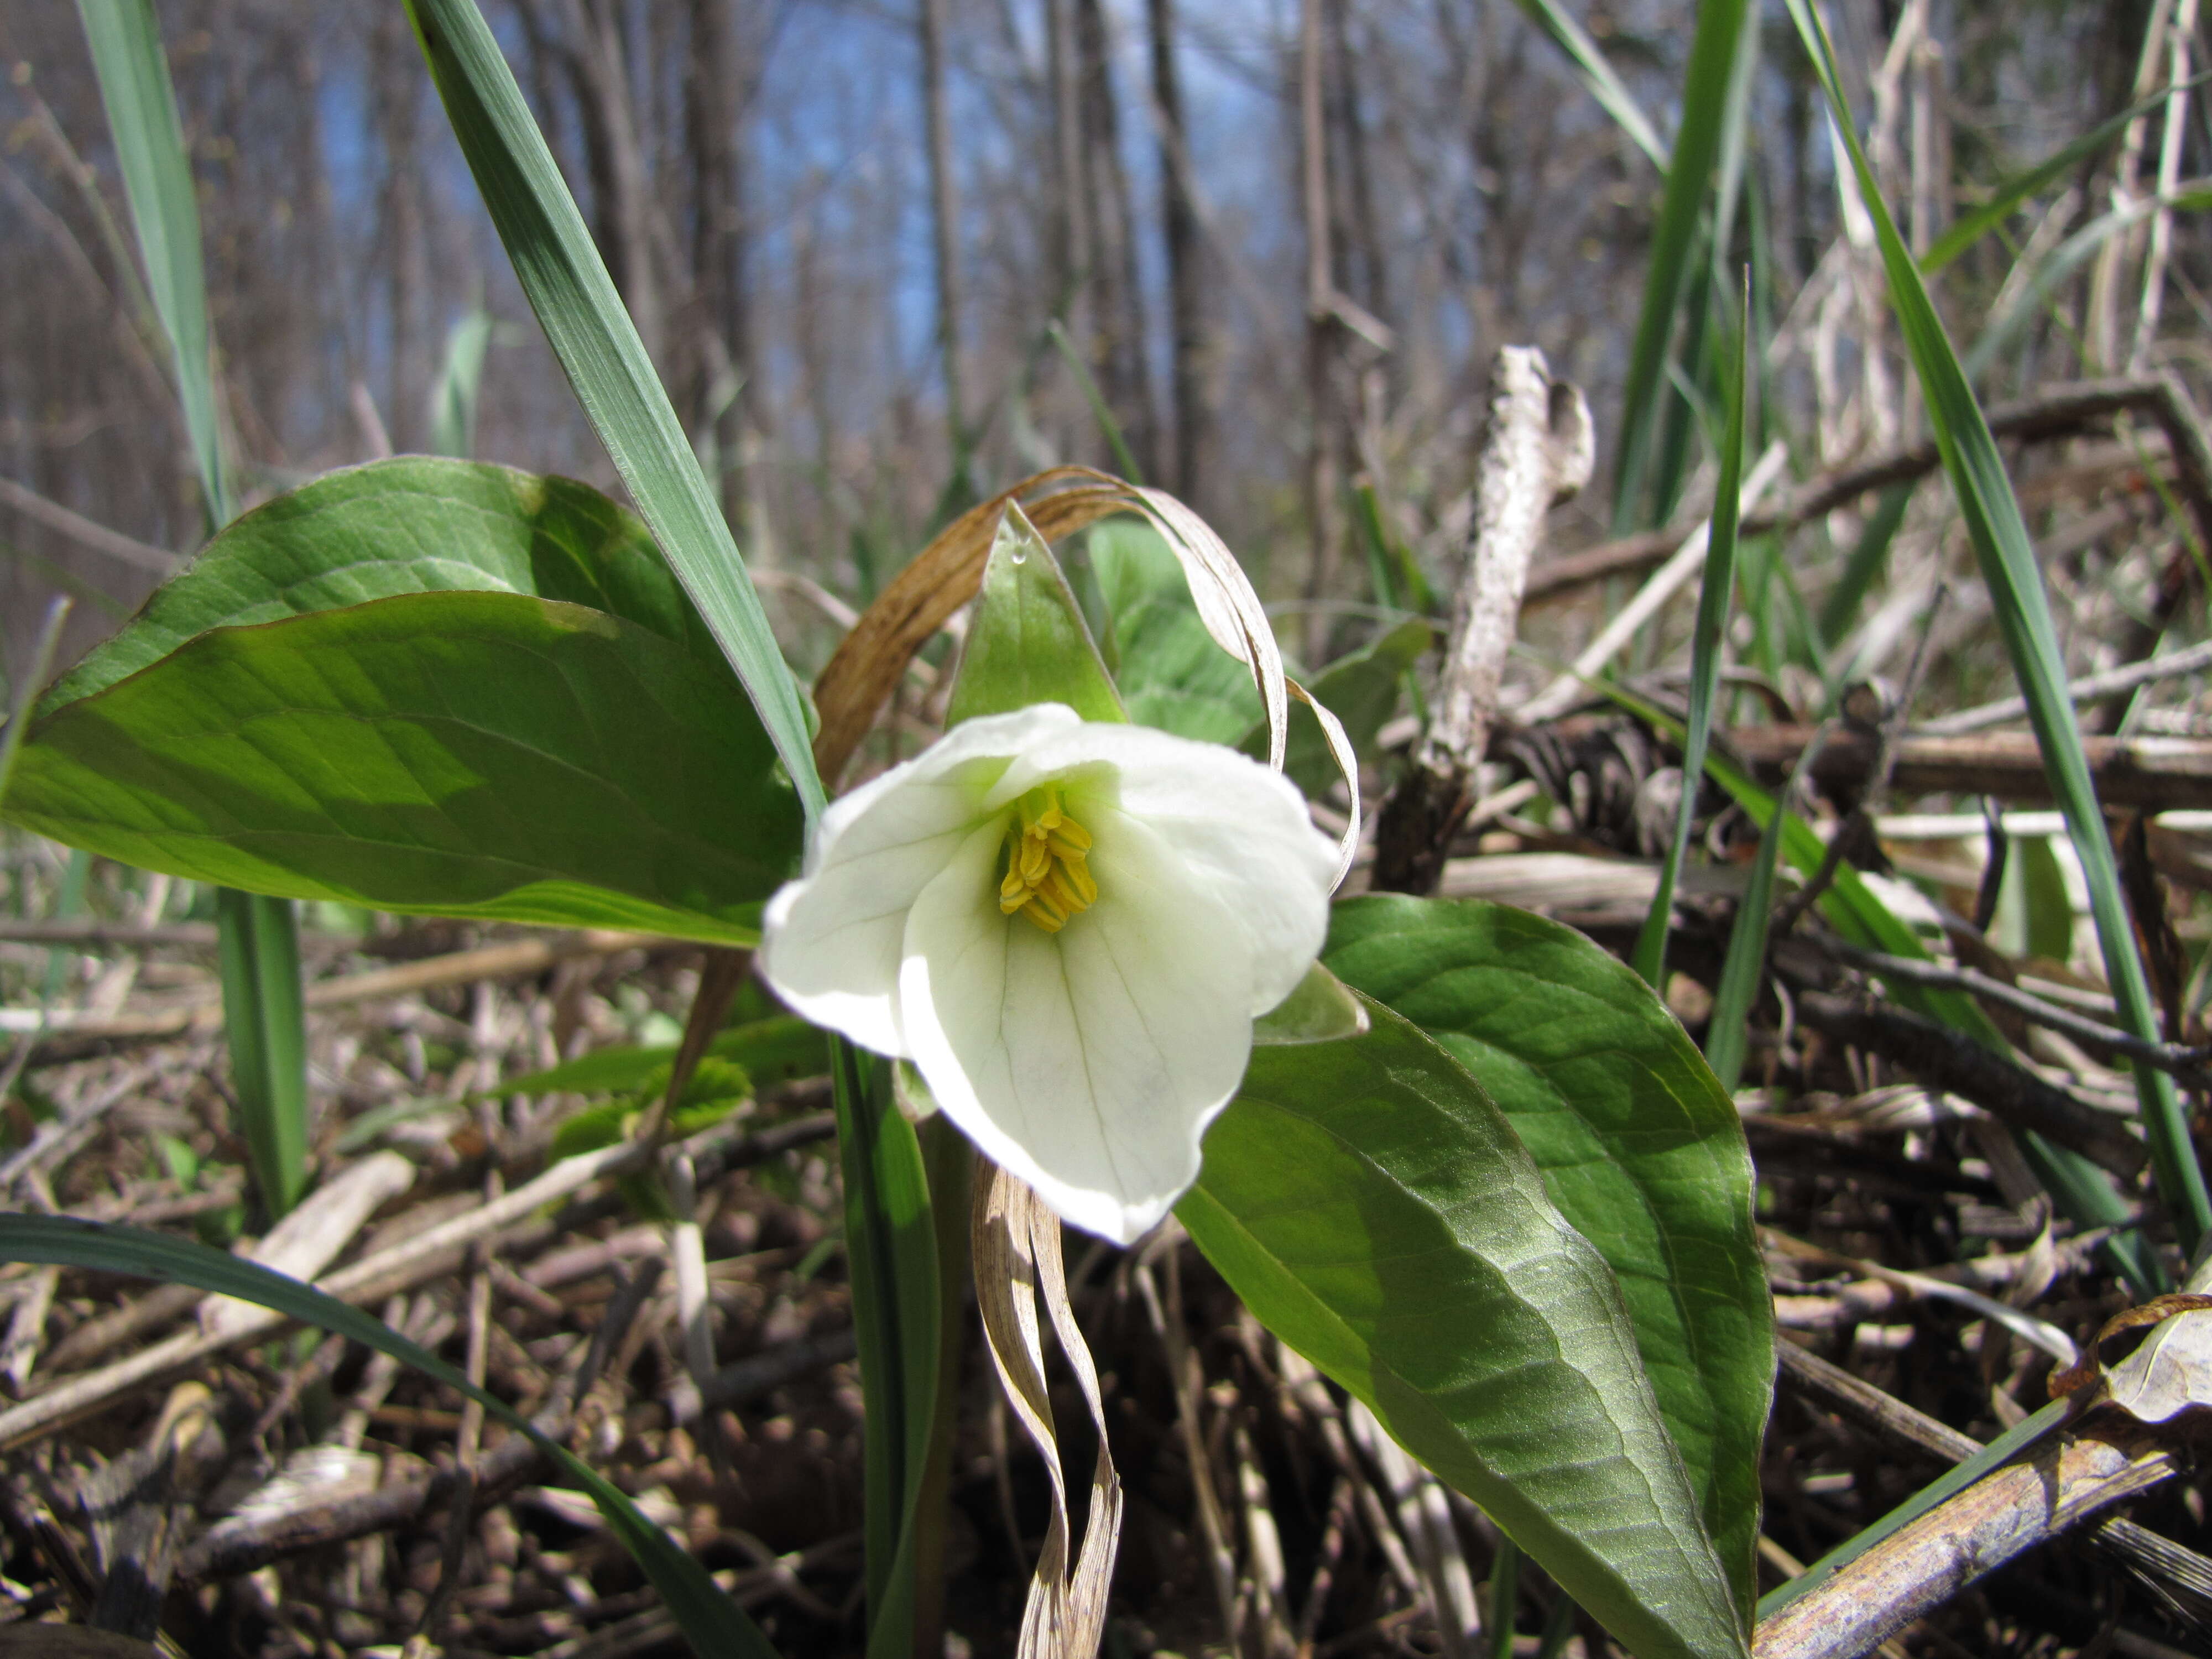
[1613,0,1745,533]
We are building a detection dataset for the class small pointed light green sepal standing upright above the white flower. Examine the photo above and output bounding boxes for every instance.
[945,502,1128,730]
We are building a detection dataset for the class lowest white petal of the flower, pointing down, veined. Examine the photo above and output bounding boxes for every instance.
[900,810,1252,1243]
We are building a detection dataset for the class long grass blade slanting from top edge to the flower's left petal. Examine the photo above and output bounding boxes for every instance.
[407,0,825,823]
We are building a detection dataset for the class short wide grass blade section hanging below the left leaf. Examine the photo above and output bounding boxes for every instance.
[215,887,307,1221]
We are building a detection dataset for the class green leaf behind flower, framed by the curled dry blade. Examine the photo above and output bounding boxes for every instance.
[1088,520,1265,743]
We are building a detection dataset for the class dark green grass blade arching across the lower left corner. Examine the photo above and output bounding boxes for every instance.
[0,1214,776,1659]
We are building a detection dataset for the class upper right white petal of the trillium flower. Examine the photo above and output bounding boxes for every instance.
[991,726,1336,1015]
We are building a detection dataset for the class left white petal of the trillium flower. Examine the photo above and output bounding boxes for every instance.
[761,703,1082,1055]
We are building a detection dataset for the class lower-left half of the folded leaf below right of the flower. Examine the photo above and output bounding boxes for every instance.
[1177,1002,1747,1659]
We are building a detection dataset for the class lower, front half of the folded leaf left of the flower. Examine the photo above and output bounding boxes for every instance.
[0,593,799,945]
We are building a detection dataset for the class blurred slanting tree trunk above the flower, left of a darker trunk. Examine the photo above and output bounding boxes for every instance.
[1075,0,1157,487]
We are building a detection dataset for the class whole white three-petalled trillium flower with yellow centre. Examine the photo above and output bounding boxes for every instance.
[761,703,1336,1243]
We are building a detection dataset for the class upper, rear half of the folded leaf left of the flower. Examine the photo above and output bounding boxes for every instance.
[40,456,721,714]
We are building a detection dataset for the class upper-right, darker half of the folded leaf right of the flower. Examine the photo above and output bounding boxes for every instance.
[1323,894,1774,1619]
